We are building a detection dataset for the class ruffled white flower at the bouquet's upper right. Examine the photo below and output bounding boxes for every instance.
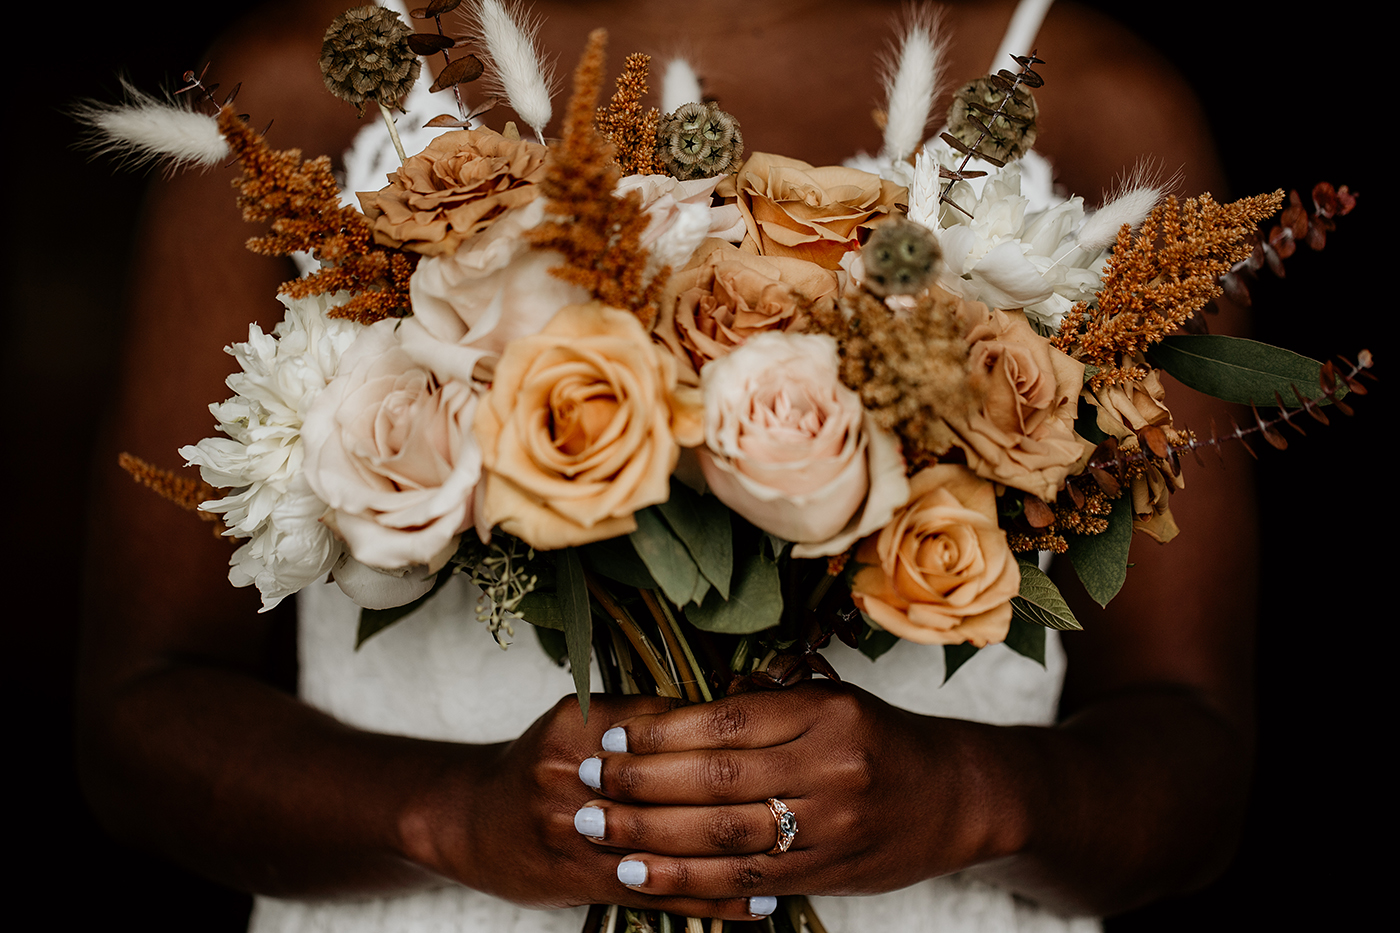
[909,140,1107,328]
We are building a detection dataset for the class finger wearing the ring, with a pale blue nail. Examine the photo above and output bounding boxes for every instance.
[574,800,778,856]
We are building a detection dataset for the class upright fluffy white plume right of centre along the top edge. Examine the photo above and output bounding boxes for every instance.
[881,6,946,161]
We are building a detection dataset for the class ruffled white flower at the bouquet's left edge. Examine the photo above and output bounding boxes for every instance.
[179,293,363,611]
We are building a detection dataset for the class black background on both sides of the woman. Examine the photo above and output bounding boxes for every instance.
[8,0,1400,933]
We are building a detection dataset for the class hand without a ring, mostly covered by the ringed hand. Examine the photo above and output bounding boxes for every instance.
[403,695,795,919]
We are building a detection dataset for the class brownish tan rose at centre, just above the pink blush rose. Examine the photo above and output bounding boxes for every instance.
[655,240,837,385]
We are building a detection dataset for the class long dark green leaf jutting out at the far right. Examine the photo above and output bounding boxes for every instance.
[1147,333,1340,408]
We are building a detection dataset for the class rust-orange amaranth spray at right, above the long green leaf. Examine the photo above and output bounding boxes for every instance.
[1054,191,1284,387]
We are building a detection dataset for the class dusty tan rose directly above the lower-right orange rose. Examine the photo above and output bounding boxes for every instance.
[946,303,1093,502]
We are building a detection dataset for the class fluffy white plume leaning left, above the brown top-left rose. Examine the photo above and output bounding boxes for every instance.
[470,0,554,143]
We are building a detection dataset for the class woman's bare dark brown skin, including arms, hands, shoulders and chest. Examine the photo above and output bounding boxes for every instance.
[80,0,1254,918]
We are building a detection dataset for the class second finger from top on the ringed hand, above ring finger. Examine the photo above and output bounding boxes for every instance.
[578,744,806,806]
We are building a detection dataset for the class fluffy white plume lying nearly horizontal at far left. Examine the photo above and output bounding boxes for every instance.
[73,81,228,168]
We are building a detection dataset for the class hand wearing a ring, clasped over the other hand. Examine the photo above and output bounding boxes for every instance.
[577,681,1021,898]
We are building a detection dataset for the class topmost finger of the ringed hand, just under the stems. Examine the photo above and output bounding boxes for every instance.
[602,691,813,755]
